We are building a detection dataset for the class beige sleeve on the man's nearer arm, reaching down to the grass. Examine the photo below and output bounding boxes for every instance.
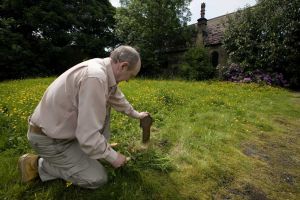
[75,78,118,163]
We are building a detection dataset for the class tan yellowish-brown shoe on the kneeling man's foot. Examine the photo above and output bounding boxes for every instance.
[18,153,38,183]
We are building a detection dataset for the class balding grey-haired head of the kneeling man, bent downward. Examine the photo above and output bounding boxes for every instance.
[110,46,141,83]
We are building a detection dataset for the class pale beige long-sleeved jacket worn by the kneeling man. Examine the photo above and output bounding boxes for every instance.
[30,58,138,163]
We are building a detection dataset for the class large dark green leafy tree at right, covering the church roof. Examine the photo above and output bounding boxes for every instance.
[224,0,300,87]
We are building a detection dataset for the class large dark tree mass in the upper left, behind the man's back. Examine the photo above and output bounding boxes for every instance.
[0,0,116,79]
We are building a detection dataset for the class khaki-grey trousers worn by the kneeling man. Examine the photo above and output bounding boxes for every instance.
[27,109,110,189]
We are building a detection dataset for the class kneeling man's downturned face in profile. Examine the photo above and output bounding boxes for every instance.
[115,61,141,83]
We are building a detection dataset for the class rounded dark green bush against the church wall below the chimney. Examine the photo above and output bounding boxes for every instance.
[179,47,215,80]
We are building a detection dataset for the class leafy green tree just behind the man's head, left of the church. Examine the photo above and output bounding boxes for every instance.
[115,0,191,75]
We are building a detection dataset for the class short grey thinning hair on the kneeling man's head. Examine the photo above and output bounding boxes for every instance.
[110,45,141,70]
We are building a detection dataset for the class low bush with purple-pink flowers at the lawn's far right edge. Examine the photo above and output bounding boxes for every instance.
[217,63,288,87]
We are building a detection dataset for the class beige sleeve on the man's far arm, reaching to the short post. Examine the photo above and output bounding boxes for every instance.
[108,86,139,118]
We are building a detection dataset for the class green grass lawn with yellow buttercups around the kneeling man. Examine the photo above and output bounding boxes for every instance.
[0,78,300,200]
